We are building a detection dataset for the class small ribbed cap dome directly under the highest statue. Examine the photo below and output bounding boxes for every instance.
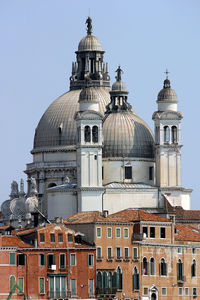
[78,35,102,51]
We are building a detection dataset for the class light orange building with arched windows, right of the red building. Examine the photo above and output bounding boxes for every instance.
[65,209,200,300]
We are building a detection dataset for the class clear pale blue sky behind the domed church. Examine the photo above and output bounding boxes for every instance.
[0,0,200,209]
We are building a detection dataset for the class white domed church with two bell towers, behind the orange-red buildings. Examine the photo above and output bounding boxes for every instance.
[1,17,192,221]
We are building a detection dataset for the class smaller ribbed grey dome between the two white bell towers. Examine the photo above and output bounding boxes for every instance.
[103,111,154,158]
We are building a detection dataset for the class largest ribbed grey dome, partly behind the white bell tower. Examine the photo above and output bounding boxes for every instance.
[34,88,110,149]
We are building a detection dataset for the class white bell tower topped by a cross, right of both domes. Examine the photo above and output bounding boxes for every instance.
[152,71,183,187]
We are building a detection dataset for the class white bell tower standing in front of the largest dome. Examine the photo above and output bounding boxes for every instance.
[76,83,104,211]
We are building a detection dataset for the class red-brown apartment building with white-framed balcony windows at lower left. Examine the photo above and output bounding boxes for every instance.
[0,224,96,299]
